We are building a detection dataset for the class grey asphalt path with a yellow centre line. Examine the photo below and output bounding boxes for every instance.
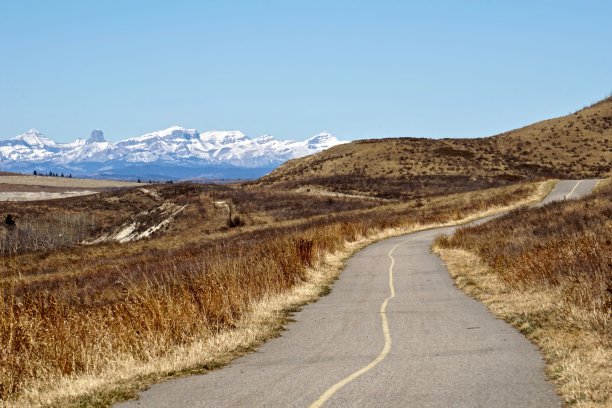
[119,180,596,408]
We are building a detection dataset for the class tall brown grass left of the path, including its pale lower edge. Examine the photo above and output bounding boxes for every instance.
[0,183,542,405]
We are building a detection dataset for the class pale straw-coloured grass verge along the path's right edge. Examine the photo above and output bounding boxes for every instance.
[434,248,612,407]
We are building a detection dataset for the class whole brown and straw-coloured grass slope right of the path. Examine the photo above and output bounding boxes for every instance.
[436,179,612,407]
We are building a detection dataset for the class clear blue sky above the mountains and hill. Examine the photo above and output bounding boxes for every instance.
[0,0,612,141]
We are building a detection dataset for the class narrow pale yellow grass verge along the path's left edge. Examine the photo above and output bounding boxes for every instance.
[7,181,555,407]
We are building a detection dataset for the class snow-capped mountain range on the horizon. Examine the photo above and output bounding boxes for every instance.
[0,126,345,177]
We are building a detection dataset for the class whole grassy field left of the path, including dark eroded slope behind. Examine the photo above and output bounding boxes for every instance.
[0,183,545,406]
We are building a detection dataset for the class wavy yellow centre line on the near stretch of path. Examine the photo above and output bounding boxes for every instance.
[310,241,406,408]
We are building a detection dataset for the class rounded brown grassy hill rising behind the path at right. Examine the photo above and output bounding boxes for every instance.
[260,97,612,198]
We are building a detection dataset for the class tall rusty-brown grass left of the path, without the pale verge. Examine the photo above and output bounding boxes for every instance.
[0,183,538,400]
